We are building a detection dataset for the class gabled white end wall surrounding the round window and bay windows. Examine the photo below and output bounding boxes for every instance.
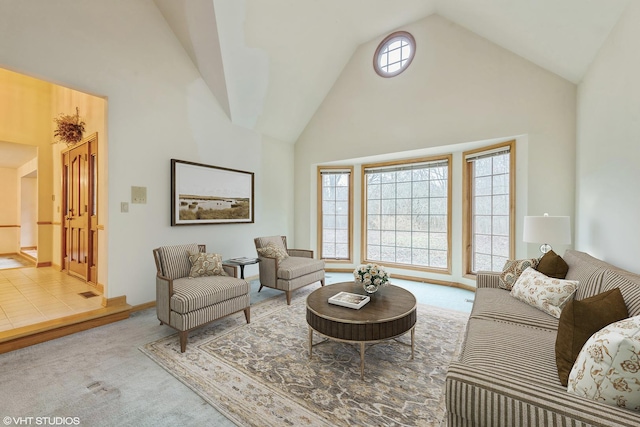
[295,15,576,282]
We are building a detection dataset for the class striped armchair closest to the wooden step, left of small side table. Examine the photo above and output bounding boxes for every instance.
[153,243,251,353]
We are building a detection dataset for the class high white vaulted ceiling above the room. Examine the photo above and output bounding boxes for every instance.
[155,0,630,143]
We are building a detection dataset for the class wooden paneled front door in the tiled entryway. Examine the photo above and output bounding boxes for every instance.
[62,135,97,283]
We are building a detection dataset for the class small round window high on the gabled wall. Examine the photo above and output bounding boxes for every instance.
[373,31,416,77]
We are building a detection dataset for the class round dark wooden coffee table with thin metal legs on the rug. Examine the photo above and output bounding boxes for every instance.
[307,282,417,378]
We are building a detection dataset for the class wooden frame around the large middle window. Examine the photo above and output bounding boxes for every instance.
[360,154,453,274]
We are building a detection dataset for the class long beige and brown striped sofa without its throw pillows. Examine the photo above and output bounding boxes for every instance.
[445,250,640,427]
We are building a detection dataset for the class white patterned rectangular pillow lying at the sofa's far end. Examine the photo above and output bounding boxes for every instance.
[511,267,578,318]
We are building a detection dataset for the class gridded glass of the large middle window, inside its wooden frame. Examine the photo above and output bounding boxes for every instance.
[362,156,451,272]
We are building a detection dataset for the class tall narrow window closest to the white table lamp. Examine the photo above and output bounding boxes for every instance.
[463,141,515,274]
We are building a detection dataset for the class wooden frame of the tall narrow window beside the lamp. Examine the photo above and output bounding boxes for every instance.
[462,140,516,279]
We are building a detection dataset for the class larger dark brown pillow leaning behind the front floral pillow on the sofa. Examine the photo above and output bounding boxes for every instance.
[556,288,629,386]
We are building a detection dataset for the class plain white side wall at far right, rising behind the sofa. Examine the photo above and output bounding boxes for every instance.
[576,2,640,273]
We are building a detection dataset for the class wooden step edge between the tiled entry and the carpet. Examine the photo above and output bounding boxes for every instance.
[0,304,131,354]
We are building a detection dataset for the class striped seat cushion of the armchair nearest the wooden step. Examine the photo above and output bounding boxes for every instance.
[169,276,249,314]
